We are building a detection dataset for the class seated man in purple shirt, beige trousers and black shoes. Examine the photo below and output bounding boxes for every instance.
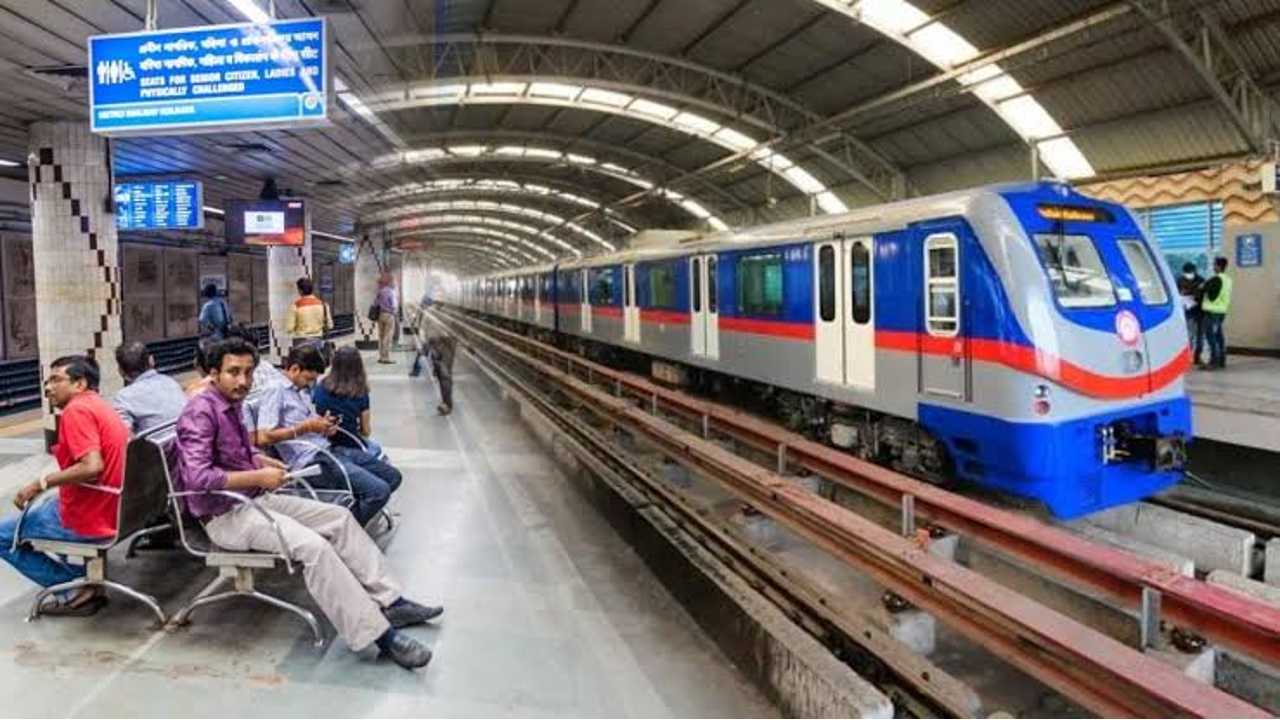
[177,338,444,669]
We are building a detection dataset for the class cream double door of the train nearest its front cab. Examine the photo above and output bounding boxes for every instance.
[813,234,876,389]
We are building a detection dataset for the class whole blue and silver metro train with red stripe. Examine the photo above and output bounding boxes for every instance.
[456,182,1192,518]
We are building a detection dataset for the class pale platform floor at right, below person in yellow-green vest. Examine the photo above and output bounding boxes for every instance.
[1187,355,1280,452]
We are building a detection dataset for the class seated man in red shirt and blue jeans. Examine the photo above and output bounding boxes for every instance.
[0,355,129,616]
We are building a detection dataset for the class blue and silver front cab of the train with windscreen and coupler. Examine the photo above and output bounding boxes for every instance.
[936,183,1192,518]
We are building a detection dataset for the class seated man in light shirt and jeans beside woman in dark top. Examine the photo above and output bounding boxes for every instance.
[255,345,402,525]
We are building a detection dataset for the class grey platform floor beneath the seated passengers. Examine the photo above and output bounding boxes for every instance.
[0,348,777,717]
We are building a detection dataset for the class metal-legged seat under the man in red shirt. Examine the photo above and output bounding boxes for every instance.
[13,425,172,625]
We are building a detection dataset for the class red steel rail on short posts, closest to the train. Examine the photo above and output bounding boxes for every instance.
[437,304,1280,666]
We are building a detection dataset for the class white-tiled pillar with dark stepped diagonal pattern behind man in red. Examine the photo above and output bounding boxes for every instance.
[27,120,122,441]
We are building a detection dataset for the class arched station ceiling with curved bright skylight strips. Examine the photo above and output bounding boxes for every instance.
[0,0,1280,274]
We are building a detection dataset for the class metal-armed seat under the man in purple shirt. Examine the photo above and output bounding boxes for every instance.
[140,432,324,647]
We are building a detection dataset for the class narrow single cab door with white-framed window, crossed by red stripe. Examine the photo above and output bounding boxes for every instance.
[918,228,970,400]
